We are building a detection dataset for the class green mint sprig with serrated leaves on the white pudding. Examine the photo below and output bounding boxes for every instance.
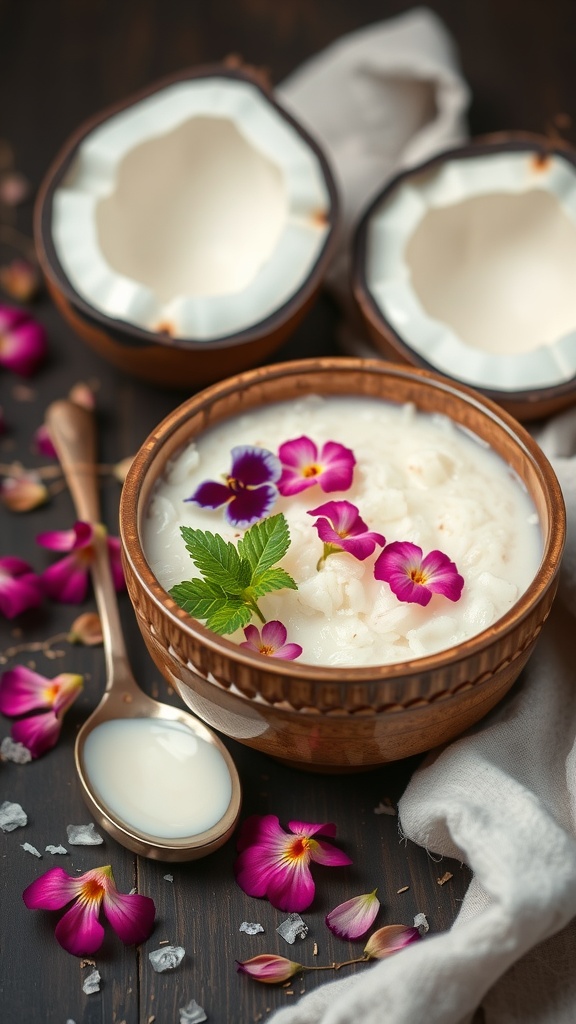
[170,512,298,635]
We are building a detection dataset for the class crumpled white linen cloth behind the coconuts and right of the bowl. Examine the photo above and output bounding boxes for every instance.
[271,8,576,1024]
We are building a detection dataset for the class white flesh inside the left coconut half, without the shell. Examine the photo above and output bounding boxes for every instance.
[52,77,331,341]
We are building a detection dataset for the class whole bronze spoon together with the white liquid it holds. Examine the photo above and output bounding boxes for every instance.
[46,400,241,861]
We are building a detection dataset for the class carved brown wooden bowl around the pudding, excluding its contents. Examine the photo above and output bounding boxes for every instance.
[120,358,565,771]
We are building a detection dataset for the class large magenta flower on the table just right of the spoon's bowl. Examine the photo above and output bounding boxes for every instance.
[234,814,352,912]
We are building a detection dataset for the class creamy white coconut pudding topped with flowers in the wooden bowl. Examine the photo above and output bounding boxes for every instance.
[141,396,542,667]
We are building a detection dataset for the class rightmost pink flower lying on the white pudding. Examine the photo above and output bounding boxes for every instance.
[374,541,464,606]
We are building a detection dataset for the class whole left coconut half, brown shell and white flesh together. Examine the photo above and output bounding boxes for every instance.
[34,65,338,389]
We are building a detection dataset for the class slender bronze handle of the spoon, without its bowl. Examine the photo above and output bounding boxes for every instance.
[46,399,131,679]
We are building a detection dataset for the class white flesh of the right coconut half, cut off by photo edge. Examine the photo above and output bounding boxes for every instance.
[366,153,576,391]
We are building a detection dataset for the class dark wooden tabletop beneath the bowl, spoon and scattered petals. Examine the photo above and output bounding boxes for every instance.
[0,0,576,1024]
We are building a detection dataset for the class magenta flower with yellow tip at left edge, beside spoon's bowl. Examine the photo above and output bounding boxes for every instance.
[0,665,83,758]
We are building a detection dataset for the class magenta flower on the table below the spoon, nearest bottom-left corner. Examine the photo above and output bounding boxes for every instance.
[23,865,156,956]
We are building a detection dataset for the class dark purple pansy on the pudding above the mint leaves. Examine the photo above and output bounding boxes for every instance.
[184,444,282,529]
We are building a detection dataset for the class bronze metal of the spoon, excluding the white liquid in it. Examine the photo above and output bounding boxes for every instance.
[46,400,241,861]
